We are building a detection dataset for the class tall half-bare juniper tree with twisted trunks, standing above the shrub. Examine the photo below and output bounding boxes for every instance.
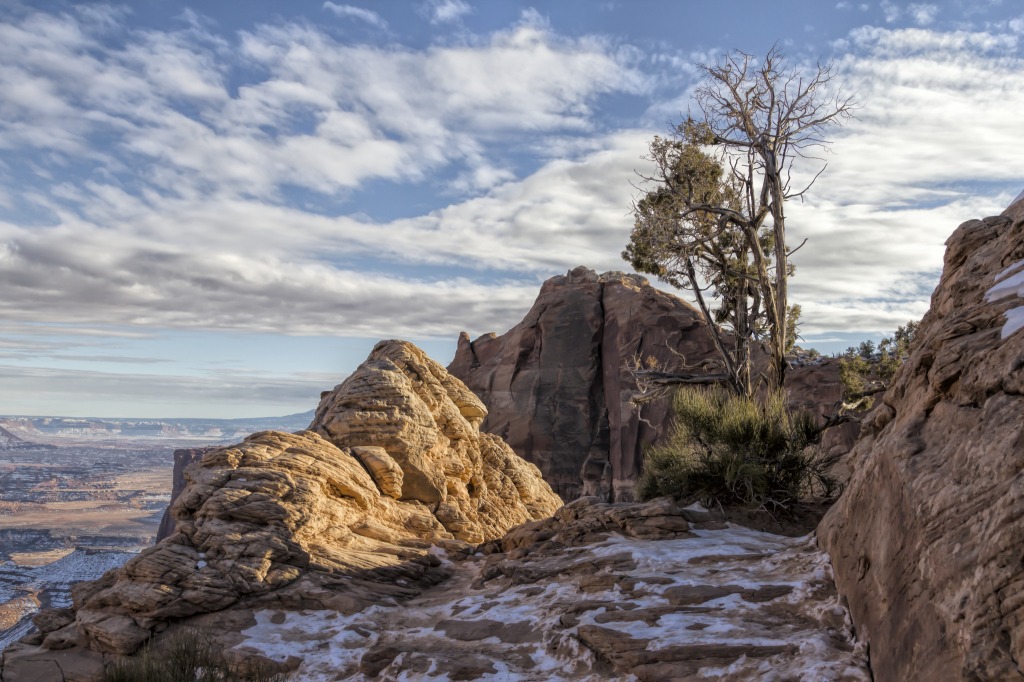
[623,47,854,395]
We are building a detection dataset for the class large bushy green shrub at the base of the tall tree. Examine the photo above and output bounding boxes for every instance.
[638,387,837,507]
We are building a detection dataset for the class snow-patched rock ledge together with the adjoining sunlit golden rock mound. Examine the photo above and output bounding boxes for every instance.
[2,341,866,682]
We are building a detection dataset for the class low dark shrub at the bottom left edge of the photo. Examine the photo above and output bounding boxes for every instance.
[103,628,286,682]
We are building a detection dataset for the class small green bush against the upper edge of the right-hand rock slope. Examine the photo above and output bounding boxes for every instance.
[839,321,920,410]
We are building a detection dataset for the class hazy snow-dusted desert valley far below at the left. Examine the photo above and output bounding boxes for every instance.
[0,411,313,648]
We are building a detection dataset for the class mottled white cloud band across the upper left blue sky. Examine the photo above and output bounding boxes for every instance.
[0,3,648,210]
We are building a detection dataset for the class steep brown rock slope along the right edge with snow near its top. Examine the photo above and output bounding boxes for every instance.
[819,193,1024,682]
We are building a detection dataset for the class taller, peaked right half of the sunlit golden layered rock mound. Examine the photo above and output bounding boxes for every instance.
[309,341,561,543]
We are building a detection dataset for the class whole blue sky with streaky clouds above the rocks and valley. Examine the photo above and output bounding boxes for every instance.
[0,0,1024,418]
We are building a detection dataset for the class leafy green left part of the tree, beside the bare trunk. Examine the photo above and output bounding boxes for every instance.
[622,118,778,395]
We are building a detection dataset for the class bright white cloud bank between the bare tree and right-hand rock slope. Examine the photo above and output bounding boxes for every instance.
[774,29,1024,332]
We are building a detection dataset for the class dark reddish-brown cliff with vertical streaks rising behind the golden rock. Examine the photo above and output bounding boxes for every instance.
[449,267,856,502]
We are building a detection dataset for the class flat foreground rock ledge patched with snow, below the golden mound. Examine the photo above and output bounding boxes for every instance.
[239,526,870,682]
